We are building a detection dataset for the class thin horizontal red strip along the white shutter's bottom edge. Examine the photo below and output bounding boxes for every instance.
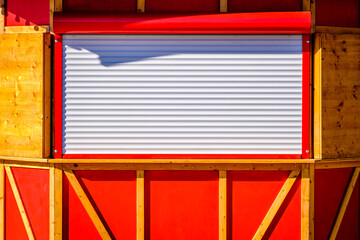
[63,154,301,159]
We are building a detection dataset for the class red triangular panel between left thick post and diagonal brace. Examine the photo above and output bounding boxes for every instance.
[63,174,102,240]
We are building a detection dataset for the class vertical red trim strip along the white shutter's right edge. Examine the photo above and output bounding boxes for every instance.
[302,34,310,159]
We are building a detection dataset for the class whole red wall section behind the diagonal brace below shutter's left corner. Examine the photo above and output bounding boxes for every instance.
[63,171,136,240]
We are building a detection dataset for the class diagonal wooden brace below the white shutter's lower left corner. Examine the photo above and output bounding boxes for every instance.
[64,170,111,240]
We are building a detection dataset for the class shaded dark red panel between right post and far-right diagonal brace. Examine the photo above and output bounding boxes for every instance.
[315,168,352,240]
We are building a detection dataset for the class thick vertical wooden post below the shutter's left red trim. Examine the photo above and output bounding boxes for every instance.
[49,164,62,240]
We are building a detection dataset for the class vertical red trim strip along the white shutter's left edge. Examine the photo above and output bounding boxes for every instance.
[54,35,62,158]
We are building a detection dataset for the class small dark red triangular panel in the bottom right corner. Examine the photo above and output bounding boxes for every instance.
[337,179,360,240]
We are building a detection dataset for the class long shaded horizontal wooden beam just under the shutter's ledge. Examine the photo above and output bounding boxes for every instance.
[64,163,301,171]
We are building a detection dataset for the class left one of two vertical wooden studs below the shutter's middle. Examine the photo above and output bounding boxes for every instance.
[136,171,145,240]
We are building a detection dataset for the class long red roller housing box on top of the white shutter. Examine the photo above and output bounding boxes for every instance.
[54,12,311,34]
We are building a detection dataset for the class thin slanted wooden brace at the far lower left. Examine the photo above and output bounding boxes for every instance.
[5,166,35,240]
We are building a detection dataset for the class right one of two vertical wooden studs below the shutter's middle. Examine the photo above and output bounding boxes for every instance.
[219,171,227,240]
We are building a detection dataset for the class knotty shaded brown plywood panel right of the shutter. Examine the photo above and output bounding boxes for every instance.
[315,33,360,158]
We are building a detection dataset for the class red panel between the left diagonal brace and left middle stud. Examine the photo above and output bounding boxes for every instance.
[75,171,136,240]
